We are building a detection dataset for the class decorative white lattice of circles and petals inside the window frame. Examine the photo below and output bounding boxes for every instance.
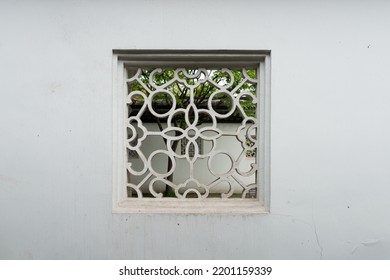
[127,68,258,199]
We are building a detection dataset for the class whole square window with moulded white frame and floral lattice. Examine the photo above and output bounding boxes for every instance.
[113,50,270,214]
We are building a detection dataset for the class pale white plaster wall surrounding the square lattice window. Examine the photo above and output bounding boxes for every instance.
[0,0,390,259]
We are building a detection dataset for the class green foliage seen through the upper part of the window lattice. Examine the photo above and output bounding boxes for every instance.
[129,69,256,128]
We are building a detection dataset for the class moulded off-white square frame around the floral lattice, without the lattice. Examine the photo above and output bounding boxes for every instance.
[112,50,271,214]
